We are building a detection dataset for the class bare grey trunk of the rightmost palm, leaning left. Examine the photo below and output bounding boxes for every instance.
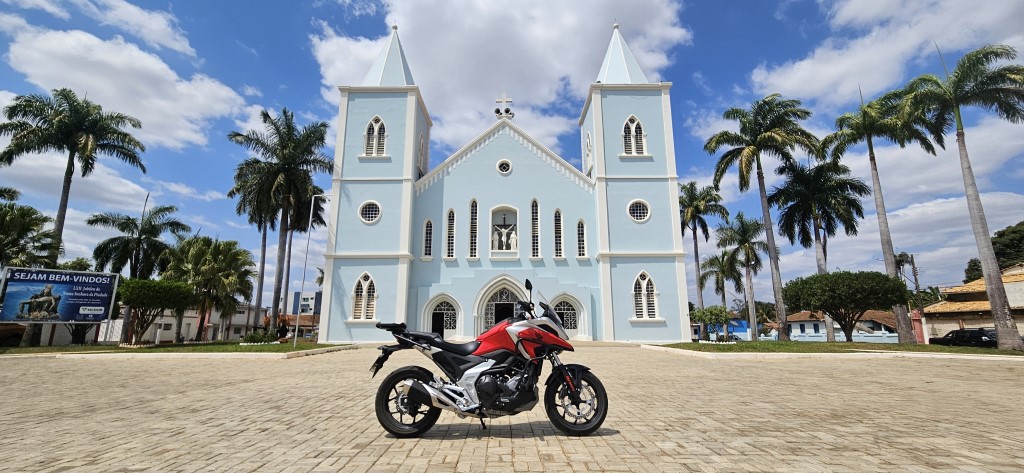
[954,127,1024,350]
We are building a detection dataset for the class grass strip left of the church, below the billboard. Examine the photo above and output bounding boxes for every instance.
[0,341,338,354]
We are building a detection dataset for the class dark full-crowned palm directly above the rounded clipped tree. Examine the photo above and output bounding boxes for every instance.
[768,160,870,274]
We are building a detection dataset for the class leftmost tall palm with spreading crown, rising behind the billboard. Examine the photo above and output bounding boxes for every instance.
[0,89,145,260]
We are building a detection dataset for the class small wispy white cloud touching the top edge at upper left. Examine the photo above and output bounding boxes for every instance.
[71,0,196,56]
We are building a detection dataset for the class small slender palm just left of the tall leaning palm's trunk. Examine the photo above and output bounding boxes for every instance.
[715,212,768,340]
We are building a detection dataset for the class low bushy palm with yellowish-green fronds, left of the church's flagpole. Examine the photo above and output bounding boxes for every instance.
[161,237,256,341]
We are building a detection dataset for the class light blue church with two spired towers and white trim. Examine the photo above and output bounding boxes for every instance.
[319,26,691,343]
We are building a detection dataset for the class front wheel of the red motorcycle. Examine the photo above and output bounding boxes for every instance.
[544,372,608,436]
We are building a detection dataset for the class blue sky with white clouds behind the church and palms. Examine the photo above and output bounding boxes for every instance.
[0,0,1024,309]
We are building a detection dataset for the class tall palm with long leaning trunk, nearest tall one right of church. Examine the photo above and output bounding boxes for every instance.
[705,93,818,340]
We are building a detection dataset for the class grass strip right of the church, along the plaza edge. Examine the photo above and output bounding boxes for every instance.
[664,342,1024,356]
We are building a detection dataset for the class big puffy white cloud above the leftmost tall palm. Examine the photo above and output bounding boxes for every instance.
[0,18,244,149]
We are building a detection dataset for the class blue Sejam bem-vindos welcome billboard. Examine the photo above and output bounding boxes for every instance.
[0,267,119,324]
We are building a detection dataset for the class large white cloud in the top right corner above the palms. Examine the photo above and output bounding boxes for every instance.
[751,0,1024,105]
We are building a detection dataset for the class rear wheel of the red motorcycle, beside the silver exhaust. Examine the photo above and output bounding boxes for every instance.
[374,367,441,438]
